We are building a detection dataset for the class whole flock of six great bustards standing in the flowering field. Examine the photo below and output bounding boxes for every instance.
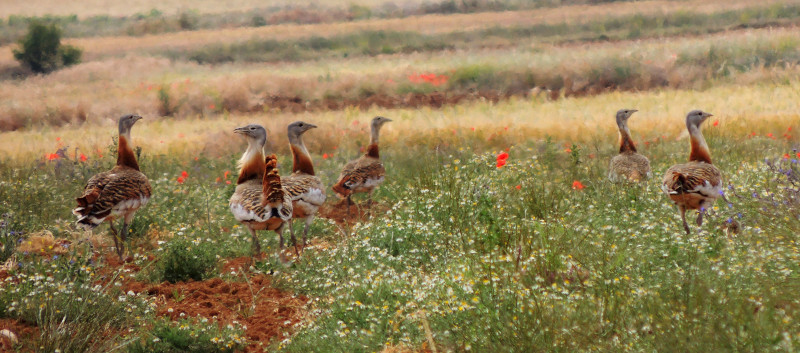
[72,109,722,262]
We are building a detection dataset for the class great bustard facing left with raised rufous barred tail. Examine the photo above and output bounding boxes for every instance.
[229,124,292,255]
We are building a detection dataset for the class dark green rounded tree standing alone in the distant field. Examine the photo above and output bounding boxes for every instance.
[14,22,83,73]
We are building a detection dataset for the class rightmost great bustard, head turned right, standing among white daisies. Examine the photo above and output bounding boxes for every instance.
[661,110,722,234]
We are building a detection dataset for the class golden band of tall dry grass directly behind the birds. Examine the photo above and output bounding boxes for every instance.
[0,80,800,164]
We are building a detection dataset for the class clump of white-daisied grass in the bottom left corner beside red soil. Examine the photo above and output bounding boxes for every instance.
[0,250,152,352]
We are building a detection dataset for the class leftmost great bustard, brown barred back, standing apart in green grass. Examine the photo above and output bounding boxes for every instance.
[72,114,152,260]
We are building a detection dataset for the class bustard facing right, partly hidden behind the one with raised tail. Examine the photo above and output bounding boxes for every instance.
[281,121,326,247]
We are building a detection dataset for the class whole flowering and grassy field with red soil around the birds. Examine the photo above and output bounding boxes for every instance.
[0,0,800,353]
